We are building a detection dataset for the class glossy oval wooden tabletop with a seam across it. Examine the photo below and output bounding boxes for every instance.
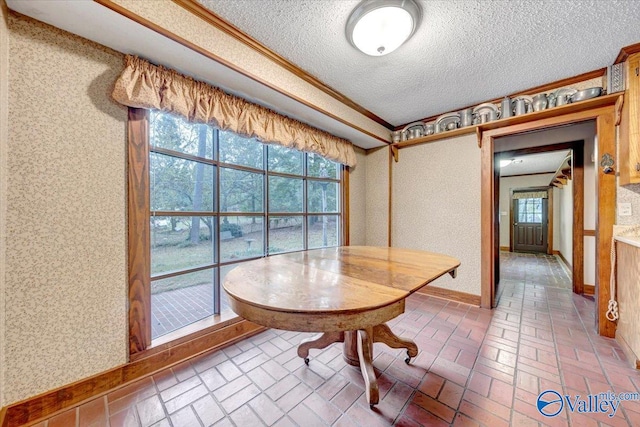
[223,246,460,314]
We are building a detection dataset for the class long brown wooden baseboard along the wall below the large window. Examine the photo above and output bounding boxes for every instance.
[0,319,266,427]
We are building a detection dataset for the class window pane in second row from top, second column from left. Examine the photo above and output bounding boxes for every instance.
[220,168,264,212]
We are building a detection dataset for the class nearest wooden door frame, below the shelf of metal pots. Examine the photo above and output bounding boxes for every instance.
[479,102,623,337]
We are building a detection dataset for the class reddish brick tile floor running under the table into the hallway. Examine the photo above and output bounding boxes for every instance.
[33,254,640,427]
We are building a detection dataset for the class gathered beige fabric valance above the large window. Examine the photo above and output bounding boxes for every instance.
[112,55,356,166]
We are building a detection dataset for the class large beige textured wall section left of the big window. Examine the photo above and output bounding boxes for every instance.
[1,11,127,404]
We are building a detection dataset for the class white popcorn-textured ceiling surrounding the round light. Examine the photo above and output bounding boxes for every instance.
[198,0,640,125]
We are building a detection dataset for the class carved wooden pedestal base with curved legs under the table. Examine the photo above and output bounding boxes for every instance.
[298,323,418,407]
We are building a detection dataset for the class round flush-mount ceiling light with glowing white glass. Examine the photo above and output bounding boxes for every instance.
[346,0,422,56]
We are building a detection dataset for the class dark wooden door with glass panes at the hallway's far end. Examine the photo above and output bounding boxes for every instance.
[513,198,548,253]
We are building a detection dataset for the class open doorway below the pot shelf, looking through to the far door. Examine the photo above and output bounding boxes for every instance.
[494,143,584,308]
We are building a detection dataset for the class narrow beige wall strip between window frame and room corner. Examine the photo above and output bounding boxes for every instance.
[349,148,367,246]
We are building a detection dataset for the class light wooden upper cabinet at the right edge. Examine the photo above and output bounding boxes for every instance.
[617,53,640,185]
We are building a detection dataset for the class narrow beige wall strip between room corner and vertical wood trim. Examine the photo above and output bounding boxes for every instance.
[366,147,390,246]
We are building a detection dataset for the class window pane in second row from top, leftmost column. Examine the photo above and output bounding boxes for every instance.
[150,153,215,212]
